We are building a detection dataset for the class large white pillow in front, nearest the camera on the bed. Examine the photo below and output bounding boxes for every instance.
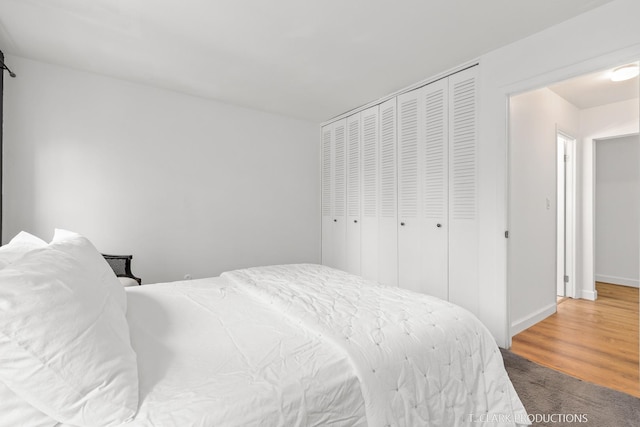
[0,233,138,426]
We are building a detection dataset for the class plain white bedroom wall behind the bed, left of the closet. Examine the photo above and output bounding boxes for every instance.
[3,57,320,283]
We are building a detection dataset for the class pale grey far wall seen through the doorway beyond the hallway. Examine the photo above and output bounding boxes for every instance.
[595,135,640,287]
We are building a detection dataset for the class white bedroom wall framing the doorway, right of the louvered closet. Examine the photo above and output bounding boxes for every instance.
[478,0,640,346]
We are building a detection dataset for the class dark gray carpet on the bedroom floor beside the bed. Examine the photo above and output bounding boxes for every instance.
[501,349,640,427]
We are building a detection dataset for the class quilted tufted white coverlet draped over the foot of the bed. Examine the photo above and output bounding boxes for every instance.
[221,265,527,427]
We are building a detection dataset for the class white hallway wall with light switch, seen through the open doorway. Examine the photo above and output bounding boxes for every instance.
[508,88,580,334]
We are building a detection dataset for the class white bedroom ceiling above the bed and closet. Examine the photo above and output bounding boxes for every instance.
[0,0,612,122]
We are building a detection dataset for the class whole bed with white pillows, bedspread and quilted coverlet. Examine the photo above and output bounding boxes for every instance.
[0,230,528,427]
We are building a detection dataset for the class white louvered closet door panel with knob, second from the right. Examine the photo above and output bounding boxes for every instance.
[420,79,449,299]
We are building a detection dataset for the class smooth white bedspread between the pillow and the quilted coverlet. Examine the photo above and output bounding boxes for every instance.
[126,278,366,427]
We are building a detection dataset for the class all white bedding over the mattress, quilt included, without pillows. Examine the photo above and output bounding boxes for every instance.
[52,265,526,427]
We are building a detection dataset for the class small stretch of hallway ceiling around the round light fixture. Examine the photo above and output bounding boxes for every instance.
[549,64,640,110]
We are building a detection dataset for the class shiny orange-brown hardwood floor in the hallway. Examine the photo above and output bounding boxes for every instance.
[511,283,640,397]
